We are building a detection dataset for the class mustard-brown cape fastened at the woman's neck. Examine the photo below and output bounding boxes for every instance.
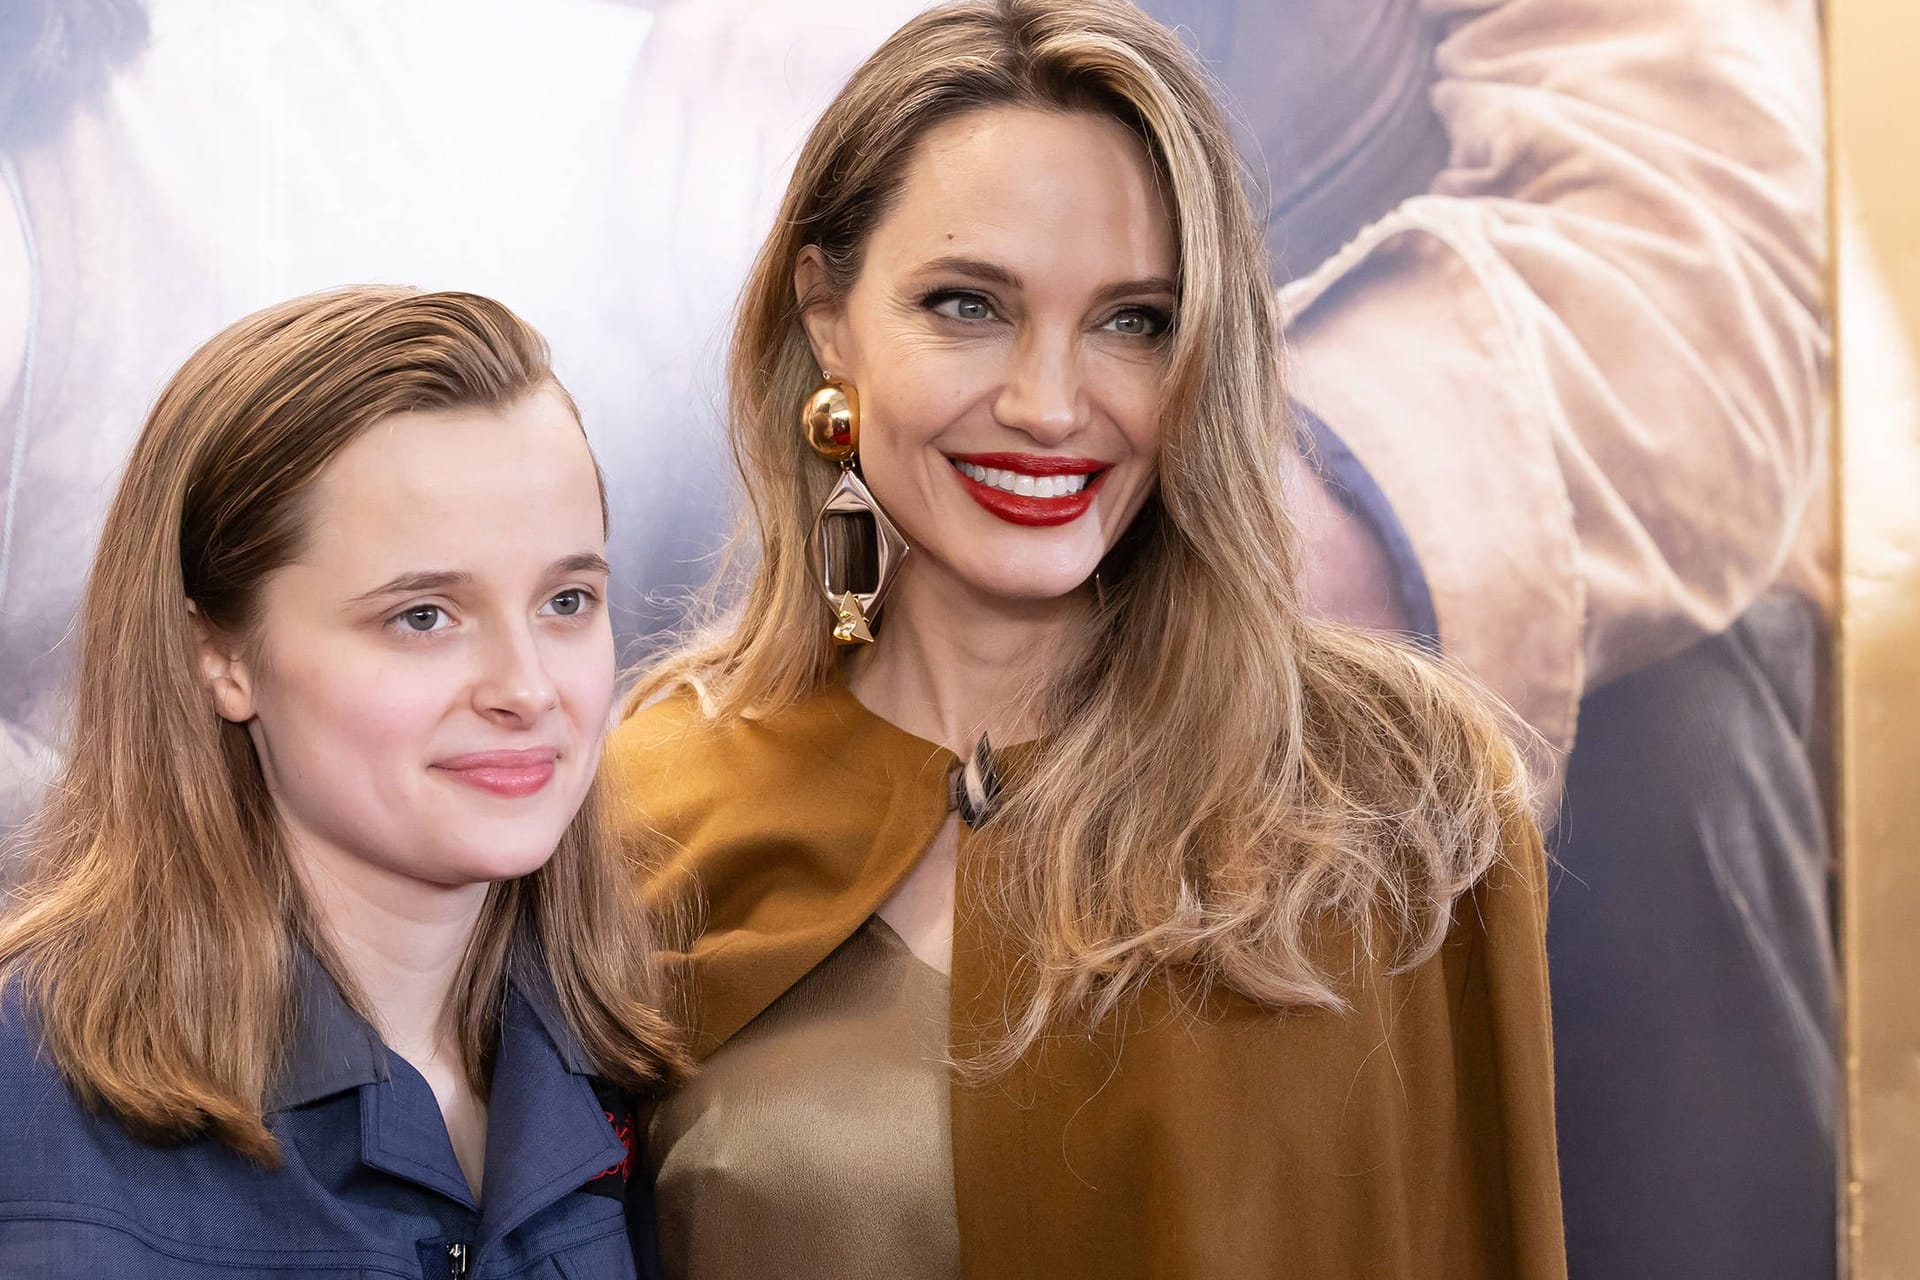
[609,683,1567,1280]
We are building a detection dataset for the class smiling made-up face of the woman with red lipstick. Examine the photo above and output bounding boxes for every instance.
[810,107,1179,606]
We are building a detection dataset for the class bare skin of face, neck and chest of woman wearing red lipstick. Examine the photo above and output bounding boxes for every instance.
[795,107,1177,971]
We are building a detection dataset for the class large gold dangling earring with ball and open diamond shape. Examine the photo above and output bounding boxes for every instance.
[801,372,910,645]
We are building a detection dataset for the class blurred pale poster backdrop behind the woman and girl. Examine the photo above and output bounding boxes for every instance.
[0,0,1891,1280]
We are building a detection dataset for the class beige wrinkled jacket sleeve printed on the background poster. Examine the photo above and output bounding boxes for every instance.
[1281,0,1828,771]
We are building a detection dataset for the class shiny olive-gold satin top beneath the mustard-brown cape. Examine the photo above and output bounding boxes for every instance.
[647,915,960,1280]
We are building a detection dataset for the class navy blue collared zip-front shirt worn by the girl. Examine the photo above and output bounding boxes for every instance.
[0,961,651,1280]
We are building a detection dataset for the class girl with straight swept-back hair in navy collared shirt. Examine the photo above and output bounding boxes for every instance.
[0,288,678,1278]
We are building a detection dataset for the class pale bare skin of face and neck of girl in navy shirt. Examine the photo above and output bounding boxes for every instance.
[202,390,614,1192]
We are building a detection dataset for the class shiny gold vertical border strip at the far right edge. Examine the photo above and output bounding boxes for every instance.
[1828,0,1920,1280]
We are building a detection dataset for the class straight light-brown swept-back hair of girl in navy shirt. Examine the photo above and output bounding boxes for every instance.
[0,286,682,1163]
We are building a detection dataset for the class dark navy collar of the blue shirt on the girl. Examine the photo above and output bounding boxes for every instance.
[267,944,595,1111]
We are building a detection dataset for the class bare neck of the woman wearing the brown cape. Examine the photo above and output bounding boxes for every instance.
[847,562,1091,756]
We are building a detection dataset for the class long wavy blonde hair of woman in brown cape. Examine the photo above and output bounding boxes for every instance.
[630,0,1526,1065]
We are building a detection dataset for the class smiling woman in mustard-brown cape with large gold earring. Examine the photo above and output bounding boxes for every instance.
[611,0,1565,1280]
